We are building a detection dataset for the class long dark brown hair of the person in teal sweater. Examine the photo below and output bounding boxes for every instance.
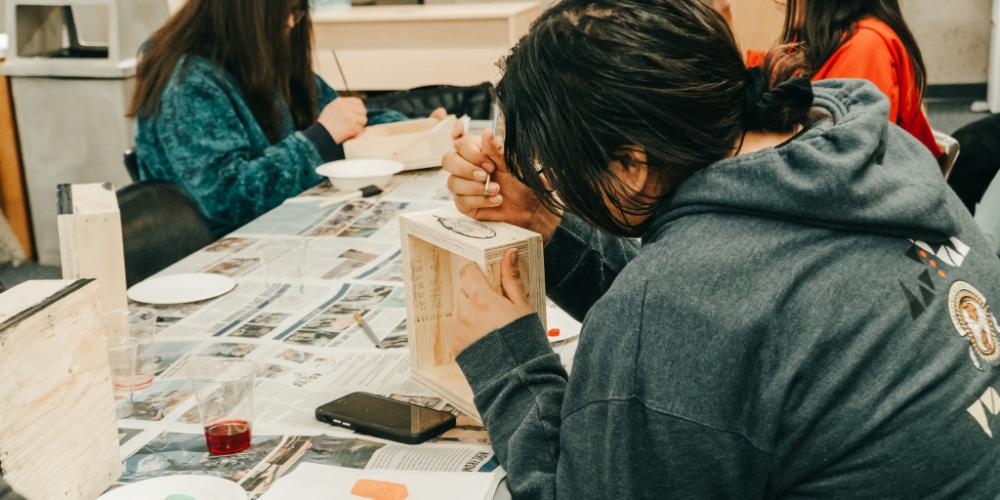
[129,0,316,143]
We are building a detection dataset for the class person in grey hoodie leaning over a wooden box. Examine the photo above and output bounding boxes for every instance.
[444,0,1000,499]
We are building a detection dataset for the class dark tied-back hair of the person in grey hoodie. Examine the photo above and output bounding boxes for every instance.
[497,0,812,236]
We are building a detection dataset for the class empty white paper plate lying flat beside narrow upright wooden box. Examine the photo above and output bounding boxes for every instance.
[128,273,236,305]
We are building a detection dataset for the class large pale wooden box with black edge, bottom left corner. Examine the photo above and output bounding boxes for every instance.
[0,280,121,500]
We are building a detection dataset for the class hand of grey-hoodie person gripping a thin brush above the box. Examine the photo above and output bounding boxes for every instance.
[441,130,562,242]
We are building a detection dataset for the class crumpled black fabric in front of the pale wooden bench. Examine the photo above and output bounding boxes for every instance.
[365,83,493,120]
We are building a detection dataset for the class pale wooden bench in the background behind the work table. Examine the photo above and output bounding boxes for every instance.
[313,2,542,90]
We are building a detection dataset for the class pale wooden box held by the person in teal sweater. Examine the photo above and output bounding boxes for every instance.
[344,115,457,170]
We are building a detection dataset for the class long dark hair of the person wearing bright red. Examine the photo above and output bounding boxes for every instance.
[781,0,927,99]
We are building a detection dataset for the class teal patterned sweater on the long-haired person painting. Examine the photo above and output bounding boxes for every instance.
[136,57,406,236]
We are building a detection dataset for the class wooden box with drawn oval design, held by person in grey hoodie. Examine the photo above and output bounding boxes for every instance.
[399,208,545,418]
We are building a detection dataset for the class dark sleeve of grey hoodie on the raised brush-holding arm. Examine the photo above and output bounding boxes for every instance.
[545,214,639,321]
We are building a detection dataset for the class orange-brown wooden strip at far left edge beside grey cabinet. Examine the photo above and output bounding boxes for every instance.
[0,60,35,259]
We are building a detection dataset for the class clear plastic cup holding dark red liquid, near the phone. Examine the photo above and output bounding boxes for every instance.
[187,357,257,455]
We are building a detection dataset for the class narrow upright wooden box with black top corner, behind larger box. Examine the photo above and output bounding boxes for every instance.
[58,184,128,336]
